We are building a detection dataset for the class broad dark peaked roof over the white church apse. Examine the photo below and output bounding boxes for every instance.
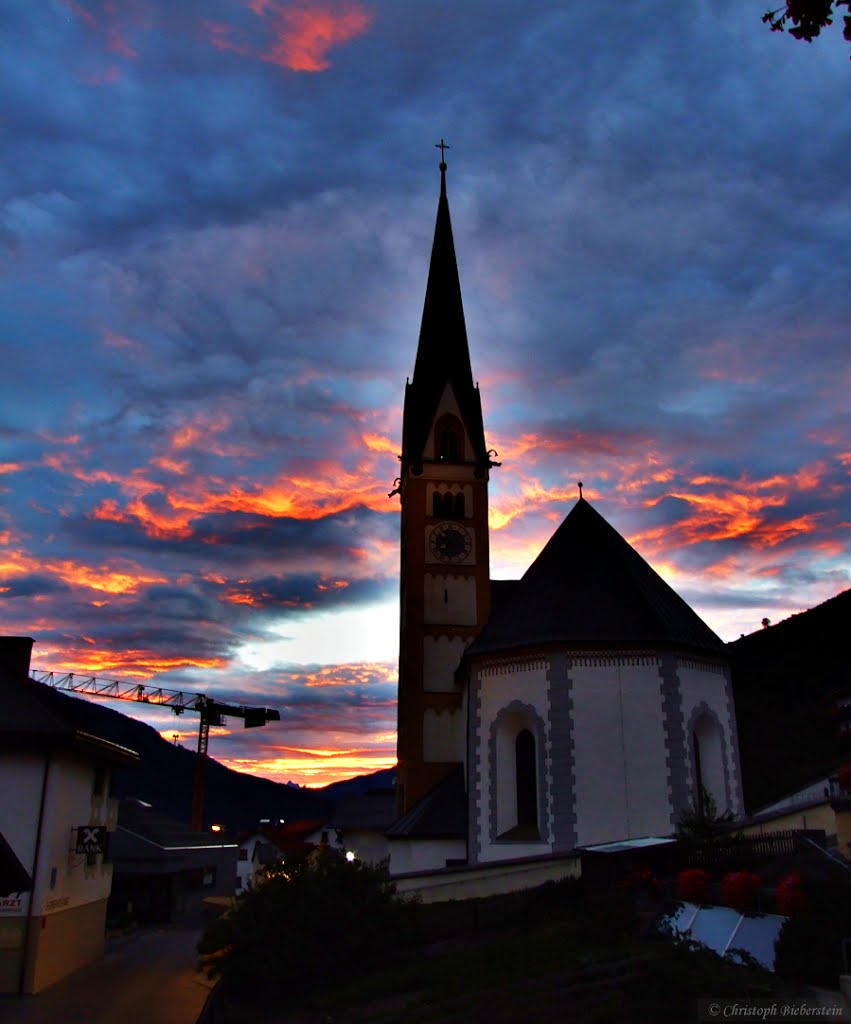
[467,498,724,656]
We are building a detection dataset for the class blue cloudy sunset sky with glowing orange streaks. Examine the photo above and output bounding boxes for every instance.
[0,0,851,785]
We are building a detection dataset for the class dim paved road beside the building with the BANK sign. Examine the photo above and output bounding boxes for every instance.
[0,927,212,1024]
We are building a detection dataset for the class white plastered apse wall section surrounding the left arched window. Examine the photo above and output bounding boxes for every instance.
[472,658,553,861]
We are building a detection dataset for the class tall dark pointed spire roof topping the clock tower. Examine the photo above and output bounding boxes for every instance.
[402,172,487,464]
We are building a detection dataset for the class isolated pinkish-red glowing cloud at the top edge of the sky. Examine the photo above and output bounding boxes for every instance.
[260,3,373,72]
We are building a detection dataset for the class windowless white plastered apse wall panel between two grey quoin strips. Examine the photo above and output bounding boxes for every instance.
[570,656,671,846]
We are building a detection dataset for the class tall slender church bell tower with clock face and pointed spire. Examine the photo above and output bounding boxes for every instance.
[395,151,492,813]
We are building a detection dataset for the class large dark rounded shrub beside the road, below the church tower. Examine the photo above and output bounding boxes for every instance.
[198,850,414,1004]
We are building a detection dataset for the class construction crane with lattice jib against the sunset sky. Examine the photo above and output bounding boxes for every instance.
[30,669,281,830]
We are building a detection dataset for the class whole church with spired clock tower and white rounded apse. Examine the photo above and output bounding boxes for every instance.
[387,150,742,874]
